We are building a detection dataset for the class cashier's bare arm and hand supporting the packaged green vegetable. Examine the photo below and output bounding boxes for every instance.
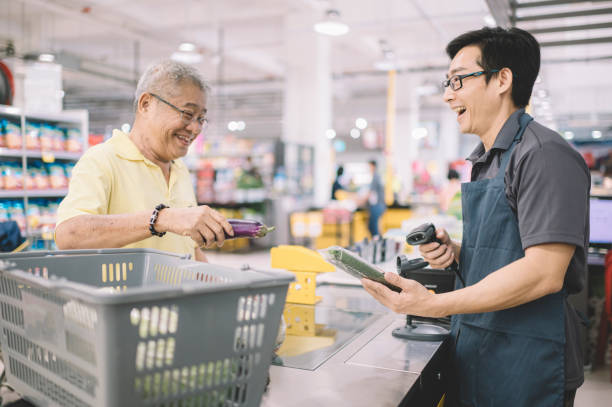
[361,243,576,317]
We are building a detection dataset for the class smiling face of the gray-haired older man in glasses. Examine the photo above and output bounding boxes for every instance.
[152,82,206,162]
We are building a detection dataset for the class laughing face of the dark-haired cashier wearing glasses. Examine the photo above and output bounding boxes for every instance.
[444,45,499,136]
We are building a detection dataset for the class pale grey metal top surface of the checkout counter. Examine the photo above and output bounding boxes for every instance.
[261,285,442,407]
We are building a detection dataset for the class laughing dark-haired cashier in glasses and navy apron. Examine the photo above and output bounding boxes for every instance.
[363,28,590,407]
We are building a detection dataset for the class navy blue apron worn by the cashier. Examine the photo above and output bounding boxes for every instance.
[449,114,565,407]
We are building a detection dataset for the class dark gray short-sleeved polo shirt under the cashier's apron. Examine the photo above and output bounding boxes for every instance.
[467,109,591,293]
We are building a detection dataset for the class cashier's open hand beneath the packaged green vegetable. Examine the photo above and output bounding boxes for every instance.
[361,273,446,318]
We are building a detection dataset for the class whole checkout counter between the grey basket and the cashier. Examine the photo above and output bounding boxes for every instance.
[261,271,449,407]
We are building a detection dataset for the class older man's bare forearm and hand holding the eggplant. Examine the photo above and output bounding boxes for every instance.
[55,205,234,250]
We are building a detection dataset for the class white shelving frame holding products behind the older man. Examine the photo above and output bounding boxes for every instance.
[0,105,89,249]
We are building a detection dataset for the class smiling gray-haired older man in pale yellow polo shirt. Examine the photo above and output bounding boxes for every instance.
[55,61,233,261]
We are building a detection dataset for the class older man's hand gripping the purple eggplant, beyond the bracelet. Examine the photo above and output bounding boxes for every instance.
[155,205,234,247]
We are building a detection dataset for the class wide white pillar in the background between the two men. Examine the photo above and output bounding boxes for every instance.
[282,12,333,206]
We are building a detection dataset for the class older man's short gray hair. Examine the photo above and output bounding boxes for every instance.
[134,59,210,111]
